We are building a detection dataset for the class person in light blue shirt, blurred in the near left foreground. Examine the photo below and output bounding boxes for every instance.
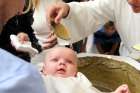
[0,0,46,93]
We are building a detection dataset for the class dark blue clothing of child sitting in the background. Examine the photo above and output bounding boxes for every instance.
[94,30,121,54]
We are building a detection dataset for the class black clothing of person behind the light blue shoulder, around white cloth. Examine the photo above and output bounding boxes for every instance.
[0,11,41,61]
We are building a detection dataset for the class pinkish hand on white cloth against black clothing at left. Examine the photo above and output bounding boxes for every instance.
[17,32,29,44]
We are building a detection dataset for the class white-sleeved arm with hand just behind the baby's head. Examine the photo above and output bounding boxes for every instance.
[31,0,58,49]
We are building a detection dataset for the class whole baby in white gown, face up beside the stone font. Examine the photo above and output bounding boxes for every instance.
[42,47,130,93]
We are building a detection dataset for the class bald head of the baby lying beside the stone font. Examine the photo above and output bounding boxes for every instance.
[43,47,77,77]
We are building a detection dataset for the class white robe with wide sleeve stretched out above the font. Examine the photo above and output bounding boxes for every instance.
[63,0,140,59]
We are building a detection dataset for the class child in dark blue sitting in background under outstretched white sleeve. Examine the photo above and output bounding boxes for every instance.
[94,21,121,55]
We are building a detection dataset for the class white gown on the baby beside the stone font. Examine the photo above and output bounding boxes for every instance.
[43,72,101,93]
